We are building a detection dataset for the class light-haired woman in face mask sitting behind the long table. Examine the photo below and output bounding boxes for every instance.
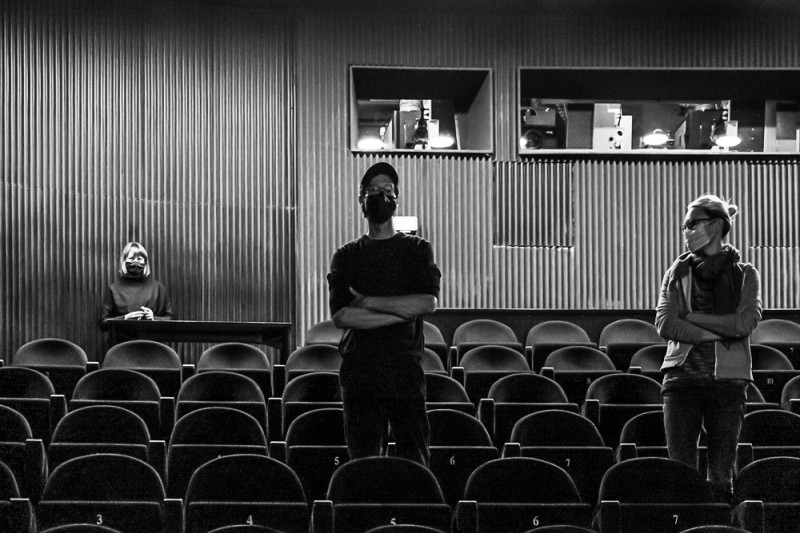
[100,242,174,327]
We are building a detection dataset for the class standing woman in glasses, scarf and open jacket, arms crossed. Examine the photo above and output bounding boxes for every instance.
[656,195,761,503]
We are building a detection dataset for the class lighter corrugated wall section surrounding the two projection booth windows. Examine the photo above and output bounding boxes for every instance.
[296,8,800,341]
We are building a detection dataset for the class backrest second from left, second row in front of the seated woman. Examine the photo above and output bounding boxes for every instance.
[72,368,161,402]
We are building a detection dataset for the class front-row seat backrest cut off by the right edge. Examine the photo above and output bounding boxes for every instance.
[733,457,800,503]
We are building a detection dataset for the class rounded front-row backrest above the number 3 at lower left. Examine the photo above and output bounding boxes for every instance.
[42,453,165,503]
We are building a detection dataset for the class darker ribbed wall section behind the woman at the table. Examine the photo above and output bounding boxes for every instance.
[0,2,295,359]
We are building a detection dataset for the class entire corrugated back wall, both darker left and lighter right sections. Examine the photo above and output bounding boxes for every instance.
[0,4,800,356]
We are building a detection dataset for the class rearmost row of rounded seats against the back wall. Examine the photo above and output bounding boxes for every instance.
[305,319,800,372]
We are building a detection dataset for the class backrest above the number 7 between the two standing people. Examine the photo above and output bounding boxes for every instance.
[511,409,604,446]
